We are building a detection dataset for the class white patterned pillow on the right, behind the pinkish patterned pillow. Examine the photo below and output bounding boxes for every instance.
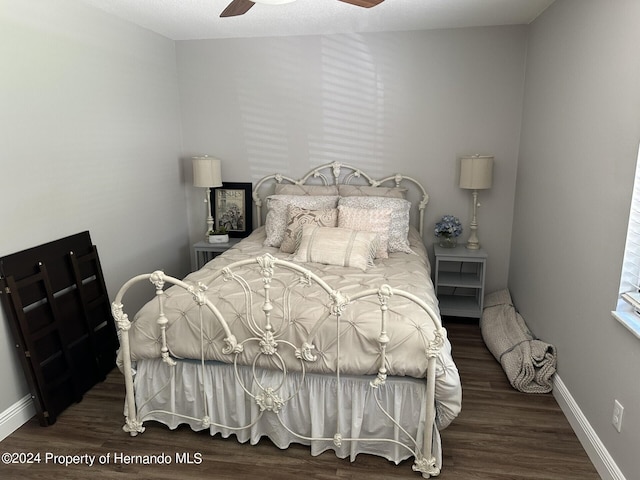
[339,197,414,253]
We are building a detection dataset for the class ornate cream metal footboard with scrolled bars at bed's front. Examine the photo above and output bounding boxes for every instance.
[112,254,446,478]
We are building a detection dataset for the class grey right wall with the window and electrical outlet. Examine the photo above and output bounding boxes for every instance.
[509,0,640,479]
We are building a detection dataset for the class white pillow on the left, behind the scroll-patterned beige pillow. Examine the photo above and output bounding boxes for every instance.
[264,195,338,247]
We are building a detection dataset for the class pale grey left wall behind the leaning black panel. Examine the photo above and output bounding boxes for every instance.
[0,0,189,412]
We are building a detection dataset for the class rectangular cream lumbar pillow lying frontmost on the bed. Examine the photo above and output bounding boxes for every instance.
[293,225,378,270]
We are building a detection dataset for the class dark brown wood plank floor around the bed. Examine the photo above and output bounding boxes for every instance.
[0,320,600,480]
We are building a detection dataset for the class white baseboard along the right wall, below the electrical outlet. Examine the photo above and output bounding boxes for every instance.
[553,374,625,480]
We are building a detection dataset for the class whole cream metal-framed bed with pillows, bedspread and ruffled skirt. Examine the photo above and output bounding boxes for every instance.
[112,163,461,478]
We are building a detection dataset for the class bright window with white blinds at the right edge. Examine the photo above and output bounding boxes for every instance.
[612,142,640,338]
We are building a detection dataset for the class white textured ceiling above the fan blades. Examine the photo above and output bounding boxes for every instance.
[80,0,554,40]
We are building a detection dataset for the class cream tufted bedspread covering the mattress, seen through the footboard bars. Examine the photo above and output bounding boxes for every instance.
[129,228,457,378]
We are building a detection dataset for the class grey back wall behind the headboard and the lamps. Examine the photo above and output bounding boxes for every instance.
[177,26,527,289]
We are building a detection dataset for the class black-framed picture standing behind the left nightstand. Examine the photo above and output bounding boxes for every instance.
[211,182,253,238]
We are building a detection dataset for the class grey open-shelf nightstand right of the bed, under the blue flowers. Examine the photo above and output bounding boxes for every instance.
[433,244,488,318]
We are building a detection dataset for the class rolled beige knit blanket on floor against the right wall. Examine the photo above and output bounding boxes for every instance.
[480,290,557,393]
